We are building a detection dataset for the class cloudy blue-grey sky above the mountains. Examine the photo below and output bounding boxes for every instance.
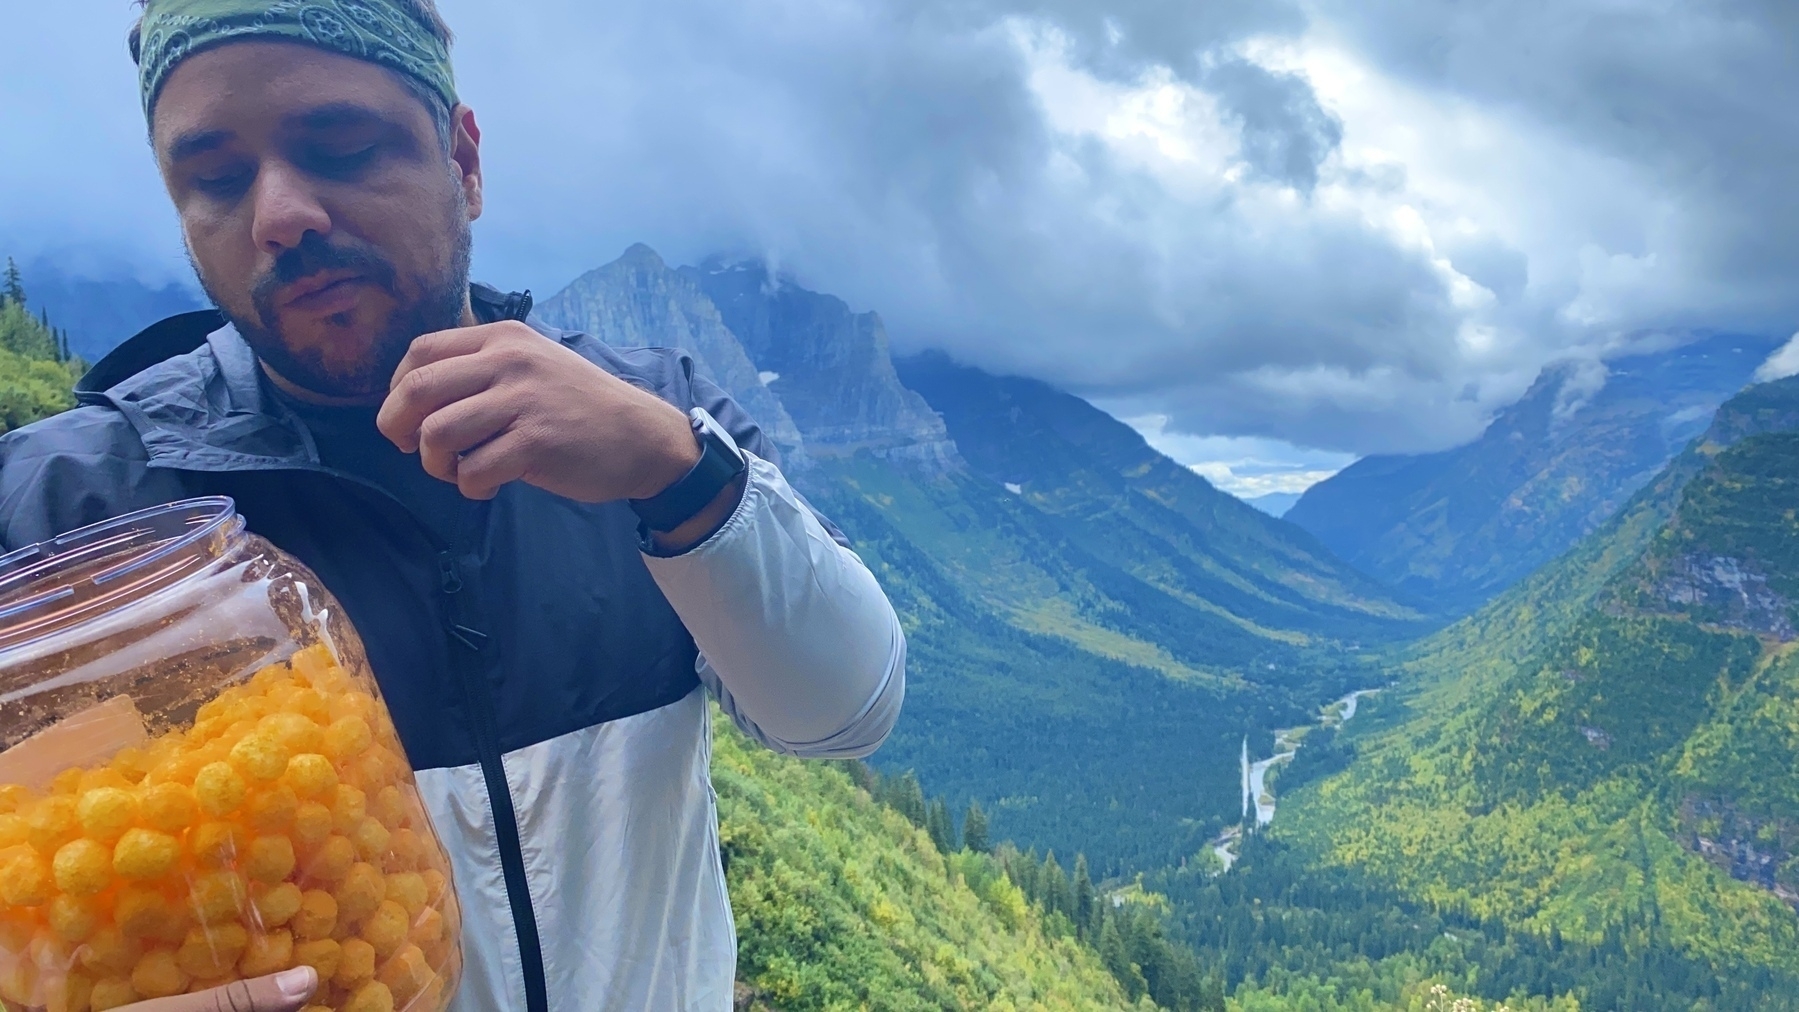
[0,0,1799,494]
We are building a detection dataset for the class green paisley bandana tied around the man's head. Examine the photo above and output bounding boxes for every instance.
[137,0,457,119]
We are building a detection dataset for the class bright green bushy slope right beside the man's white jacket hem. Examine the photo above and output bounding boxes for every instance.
[712,721,1155,1012]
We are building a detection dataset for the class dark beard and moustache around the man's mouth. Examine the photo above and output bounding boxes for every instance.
[194,211,471,397]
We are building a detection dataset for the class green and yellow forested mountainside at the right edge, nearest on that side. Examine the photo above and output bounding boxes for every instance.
[1275,379,1799,1008]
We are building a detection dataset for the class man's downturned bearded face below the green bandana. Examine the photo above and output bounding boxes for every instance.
[151,41,480,397]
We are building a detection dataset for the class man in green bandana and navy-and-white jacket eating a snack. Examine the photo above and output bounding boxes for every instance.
[0,0,905,1012]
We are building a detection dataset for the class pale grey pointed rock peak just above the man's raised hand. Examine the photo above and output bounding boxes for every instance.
[538,243,809,471]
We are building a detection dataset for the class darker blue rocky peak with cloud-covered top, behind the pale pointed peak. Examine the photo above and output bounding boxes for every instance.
[680,257,959,469]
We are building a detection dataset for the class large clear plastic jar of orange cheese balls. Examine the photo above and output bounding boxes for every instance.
[0,498,462,1012]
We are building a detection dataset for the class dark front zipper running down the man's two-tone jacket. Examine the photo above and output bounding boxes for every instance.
[437,550,550,1012]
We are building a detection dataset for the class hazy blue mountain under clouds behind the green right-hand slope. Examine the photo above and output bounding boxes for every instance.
[1286,336,1774,613]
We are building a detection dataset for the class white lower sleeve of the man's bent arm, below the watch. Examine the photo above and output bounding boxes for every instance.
[644,453,905,759]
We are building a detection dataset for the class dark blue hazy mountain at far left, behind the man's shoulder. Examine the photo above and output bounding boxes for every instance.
[20,257,207,363]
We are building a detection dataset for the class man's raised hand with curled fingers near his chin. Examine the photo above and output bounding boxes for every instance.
[376,320,700,503]
